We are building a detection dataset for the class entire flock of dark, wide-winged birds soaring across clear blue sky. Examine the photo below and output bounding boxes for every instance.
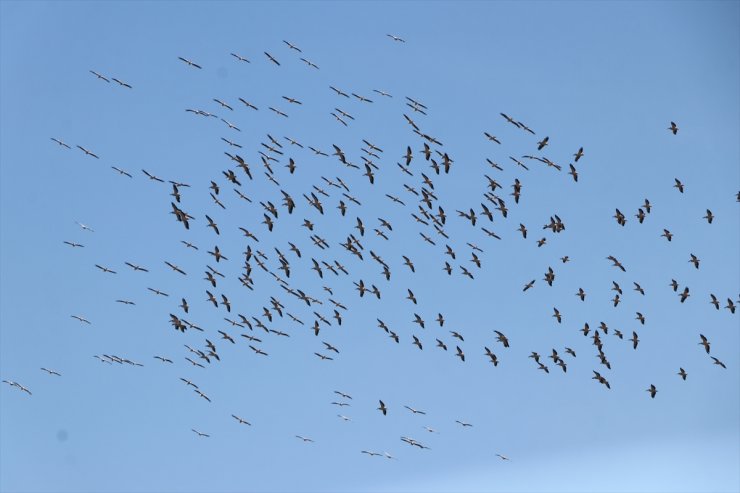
[3,34,740,466]
